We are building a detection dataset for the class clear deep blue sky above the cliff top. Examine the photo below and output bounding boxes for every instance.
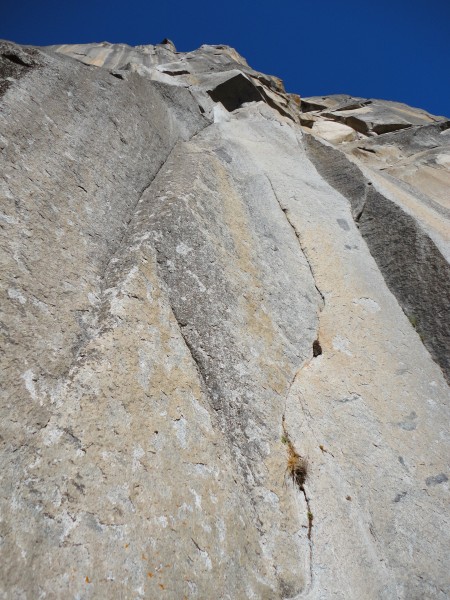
[0,0,450,117]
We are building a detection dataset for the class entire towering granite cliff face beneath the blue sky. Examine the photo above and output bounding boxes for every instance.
[0,40,450,600]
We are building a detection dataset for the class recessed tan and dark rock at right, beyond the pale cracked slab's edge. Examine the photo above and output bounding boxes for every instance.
[302,96,450,380]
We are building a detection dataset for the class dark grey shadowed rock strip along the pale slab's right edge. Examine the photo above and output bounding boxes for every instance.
[305,135,450,381]
